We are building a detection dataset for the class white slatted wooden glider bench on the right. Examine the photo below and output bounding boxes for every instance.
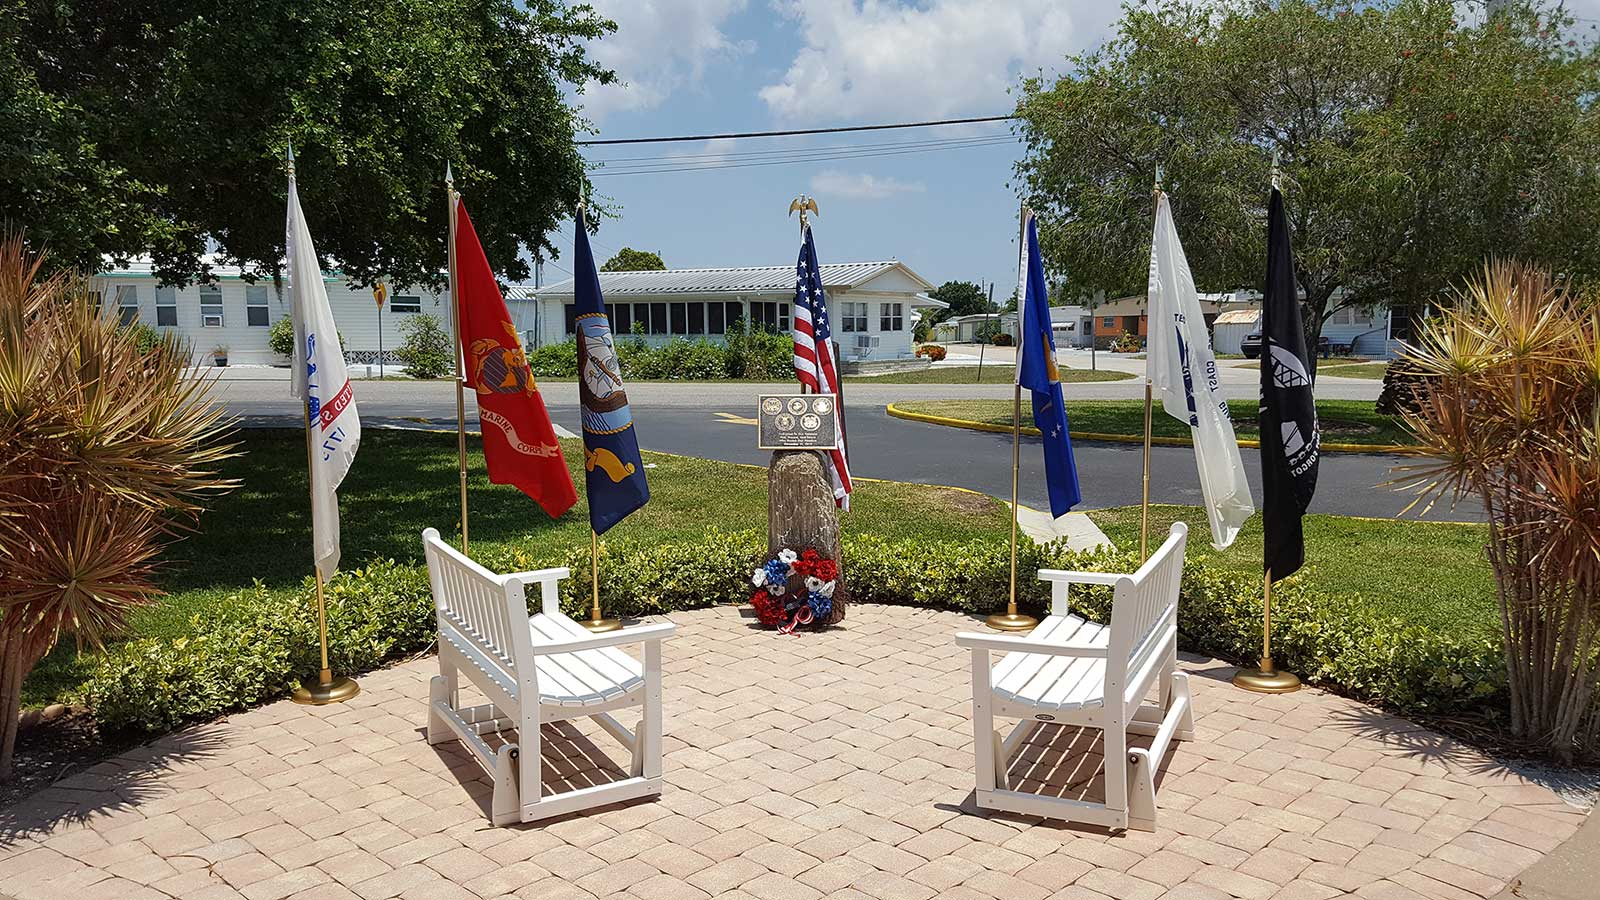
[955,522,1194,831]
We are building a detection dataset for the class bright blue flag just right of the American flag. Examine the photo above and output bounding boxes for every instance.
[1016,210,1083,516]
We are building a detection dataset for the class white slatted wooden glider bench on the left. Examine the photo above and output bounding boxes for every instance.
[422,528,677,825]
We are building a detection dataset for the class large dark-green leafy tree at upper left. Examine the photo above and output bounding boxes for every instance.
[0,0,614,285]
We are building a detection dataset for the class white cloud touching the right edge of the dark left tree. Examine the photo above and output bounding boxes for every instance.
[579,0,754,122]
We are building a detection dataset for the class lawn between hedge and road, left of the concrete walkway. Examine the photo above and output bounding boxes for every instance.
[22,429,1011,705]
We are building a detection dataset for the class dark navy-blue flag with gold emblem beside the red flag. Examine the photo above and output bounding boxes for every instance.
[573,210,650,535]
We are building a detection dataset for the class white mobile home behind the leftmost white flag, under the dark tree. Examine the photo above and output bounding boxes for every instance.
[94,258,451,365]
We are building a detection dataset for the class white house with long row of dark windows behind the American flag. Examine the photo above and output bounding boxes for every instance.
[524,259,944,360]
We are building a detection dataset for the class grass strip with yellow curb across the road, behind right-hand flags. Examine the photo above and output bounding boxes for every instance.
[894,400,1413,445]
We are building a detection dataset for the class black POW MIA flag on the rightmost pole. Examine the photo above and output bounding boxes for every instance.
[1261,187,1322,581]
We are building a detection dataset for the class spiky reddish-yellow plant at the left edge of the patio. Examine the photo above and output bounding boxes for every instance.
[0,235,232,780]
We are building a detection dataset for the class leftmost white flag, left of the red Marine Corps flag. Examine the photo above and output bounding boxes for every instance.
[288,164,362,578]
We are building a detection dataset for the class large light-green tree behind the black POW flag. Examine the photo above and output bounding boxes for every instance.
[1018,0,1600,365]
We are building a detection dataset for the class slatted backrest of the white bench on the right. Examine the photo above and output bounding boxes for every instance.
[1106,522,1189,703]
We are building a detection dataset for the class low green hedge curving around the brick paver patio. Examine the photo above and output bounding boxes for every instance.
[85,530,1506,732]
